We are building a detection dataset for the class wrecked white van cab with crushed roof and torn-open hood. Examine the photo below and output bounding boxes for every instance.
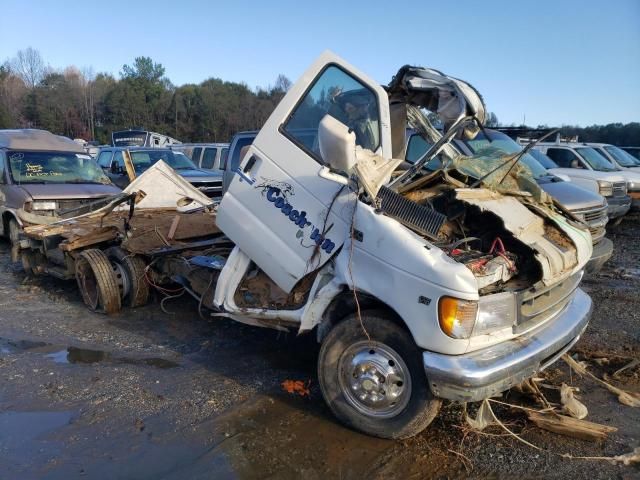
[213,52,592,438]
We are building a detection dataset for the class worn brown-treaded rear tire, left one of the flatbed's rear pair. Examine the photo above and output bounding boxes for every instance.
[76,249,121,315]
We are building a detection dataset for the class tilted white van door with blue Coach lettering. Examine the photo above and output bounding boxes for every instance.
[217,52,391,292]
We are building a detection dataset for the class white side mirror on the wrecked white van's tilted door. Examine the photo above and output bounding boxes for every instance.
[318,115,356,173]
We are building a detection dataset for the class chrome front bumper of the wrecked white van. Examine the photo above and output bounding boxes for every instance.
[422,288,592,402]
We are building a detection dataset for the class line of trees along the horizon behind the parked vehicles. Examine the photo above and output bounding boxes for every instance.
[0,47,640,146]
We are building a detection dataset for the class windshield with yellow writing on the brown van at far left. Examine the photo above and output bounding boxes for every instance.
[8,150,111,185]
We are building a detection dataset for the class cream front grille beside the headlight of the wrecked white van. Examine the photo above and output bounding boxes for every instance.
[513,271,582,333]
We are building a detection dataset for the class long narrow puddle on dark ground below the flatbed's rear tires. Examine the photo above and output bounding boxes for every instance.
[0,338,180,369]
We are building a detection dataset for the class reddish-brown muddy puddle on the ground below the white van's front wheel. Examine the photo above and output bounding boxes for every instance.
[182,395,464,479]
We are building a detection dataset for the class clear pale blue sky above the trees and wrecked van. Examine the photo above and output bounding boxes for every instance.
[0,0,640,126]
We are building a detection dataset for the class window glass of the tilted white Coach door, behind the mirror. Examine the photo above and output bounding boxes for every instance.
[284,65,380,163]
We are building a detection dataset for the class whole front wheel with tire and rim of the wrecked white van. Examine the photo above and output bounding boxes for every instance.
[318,311,441,439]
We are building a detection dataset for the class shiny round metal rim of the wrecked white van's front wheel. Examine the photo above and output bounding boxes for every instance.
[338,341,411,418]
